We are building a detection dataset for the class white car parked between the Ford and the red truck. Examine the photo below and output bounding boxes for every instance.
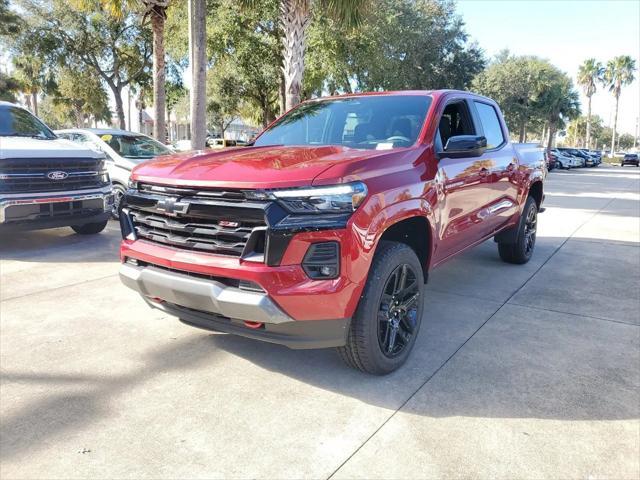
[56,128,172,218]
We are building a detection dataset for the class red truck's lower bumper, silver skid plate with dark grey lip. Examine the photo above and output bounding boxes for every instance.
[120,263,349,348]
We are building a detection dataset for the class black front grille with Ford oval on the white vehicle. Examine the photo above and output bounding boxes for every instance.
[0,158,109,193]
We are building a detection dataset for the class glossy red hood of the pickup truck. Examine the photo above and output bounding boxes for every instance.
[132,146,389,188]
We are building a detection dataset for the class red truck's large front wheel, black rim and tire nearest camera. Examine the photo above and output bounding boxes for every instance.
[337,242,424,375]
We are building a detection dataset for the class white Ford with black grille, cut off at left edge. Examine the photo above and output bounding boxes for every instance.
[0,102,113,234]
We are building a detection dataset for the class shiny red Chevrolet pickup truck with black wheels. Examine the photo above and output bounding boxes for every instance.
[120,90,546,374]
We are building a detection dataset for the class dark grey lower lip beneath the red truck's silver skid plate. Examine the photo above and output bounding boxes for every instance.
[151,298,350,349]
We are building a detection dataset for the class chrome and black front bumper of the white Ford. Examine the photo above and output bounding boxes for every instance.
[0,186,113,231]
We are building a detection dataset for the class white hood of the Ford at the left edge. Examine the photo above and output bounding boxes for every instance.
[0,137,103,160]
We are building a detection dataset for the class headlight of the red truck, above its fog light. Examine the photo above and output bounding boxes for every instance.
[269,182,367,213]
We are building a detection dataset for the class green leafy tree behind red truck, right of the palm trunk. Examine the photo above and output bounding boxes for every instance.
[305,0,485,96]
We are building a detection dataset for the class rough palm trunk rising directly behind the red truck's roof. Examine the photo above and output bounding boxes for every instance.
[280,0,310,110]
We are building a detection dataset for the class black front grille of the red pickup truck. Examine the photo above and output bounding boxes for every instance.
[125,187,267,260]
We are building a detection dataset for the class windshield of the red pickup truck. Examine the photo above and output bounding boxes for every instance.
[255,95,431,150]
